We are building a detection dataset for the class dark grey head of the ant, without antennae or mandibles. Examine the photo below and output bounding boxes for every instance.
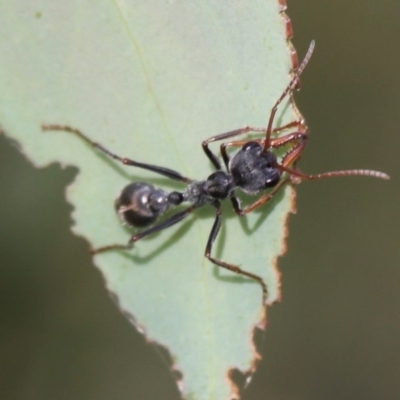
[229,142,281,195]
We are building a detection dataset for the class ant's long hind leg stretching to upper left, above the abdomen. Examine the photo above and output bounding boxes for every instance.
[42,124,192,183]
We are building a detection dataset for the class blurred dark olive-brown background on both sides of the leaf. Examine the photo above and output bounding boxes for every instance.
[0,0,400,400]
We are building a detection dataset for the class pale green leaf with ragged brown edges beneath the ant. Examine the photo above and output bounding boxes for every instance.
[0,0,297,400]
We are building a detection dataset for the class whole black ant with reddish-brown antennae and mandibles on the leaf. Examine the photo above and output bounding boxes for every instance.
[42,41,389,304]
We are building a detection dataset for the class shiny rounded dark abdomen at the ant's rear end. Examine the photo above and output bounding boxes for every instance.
[115,182,169,228]
